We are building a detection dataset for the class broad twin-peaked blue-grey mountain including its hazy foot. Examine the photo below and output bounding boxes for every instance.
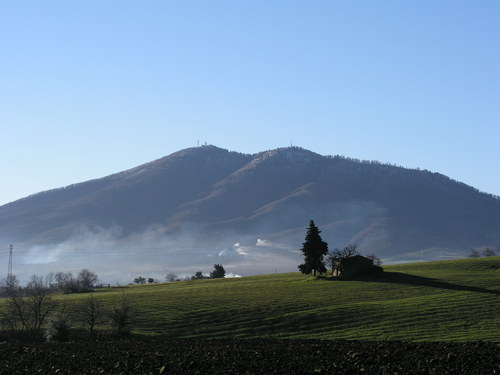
[0,146,500,282]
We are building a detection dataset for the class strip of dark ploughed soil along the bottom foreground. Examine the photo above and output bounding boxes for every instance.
[0,340,500,375]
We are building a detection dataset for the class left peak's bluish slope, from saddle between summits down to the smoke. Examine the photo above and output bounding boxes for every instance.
[0,147,249,241]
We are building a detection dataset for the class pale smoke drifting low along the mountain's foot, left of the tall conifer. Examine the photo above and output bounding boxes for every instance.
[7,225,304,285]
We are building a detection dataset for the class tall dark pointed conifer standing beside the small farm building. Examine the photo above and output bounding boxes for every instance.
[299,220,328,276]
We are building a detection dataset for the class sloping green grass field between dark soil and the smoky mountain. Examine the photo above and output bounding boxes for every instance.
[3,256,500,342]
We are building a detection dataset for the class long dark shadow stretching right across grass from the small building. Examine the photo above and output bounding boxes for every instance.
[327,272,500,295]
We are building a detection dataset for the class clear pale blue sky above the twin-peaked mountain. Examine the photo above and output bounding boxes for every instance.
[0,0,500,204]
